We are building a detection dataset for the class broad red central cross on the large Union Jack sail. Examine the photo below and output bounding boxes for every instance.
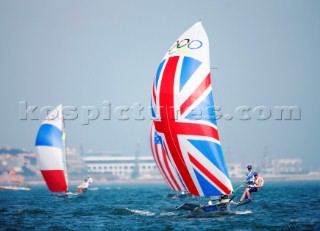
[154,56,219,196]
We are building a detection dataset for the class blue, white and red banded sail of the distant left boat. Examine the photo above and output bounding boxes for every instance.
[35,105,69,195]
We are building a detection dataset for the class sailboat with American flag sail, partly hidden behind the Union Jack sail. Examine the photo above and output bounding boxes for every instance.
[150,122,193,200]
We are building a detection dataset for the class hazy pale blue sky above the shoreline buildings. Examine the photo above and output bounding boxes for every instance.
[0,0,320,169]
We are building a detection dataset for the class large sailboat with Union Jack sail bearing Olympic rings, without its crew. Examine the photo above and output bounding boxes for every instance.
[151,22,233,212]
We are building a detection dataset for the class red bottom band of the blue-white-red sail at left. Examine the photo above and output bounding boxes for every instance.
[41,170,68,192]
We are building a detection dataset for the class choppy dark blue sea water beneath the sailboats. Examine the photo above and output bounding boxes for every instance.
[0,181,320,230]
